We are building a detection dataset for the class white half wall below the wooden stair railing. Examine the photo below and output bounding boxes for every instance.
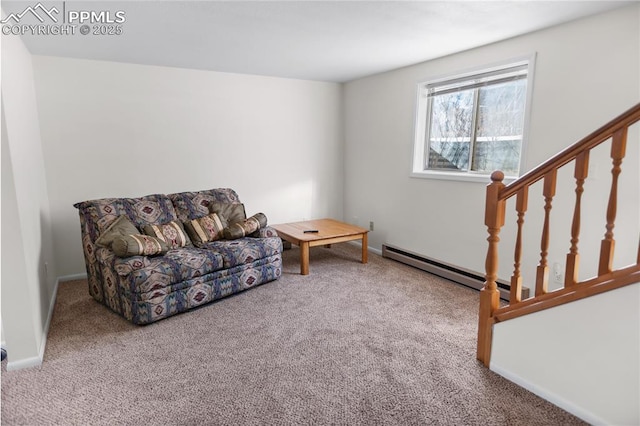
[491,283,640,425]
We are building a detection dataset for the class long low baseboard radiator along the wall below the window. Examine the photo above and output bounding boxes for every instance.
[382,244,529,301]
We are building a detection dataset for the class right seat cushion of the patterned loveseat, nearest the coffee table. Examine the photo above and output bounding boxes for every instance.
[203,237,282,268]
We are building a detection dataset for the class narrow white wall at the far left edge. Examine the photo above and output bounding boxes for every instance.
[2,30,56,369]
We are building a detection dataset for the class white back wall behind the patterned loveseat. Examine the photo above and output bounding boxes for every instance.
[34,56,343,276]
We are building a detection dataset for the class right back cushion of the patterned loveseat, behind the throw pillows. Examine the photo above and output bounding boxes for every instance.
[168,188,240,223]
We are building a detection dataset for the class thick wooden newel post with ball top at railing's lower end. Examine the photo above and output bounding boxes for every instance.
[477,171,506,367]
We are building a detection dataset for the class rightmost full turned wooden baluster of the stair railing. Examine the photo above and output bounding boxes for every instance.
[598,128,627,275]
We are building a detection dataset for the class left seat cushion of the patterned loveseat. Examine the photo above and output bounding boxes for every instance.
[114,247,225,293]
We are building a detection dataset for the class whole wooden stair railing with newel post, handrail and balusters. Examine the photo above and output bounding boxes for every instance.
[477,104,640,366]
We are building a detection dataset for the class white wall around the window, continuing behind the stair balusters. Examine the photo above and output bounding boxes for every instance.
[344,5,640,287]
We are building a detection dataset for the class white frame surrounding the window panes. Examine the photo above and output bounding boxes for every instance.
[410,53,536,184]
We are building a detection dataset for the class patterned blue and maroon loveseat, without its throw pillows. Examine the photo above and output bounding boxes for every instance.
[74,188,282,324]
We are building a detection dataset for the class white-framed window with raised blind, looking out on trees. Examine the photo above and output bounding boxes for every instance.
[412,58,533,181]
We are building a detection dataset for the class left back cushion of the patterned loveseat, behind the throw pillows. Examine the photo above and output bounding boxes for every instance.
[73,194,177,243]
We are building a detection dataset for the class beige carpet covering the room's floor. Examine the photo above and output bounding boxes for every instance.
[2,244,582,425]
